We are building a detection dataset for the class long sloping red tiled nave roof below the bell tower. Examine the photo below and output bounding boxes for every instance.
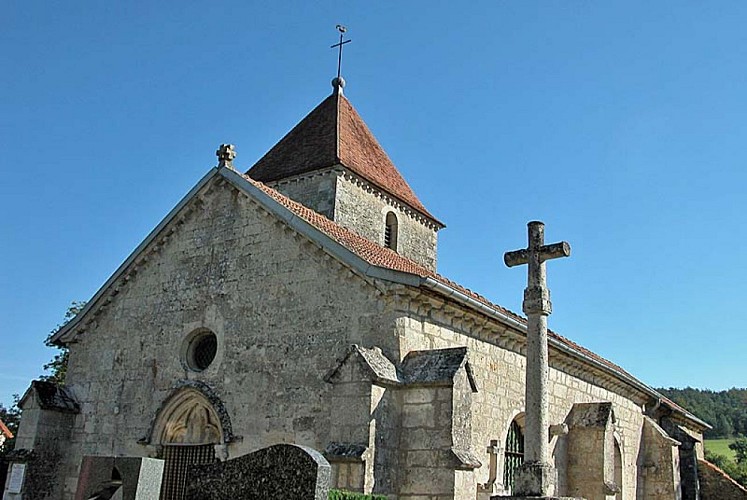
[243,175,644,382]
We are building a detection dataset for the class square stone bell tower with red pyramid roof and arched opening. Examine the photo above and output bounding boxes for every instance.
[247,81,445,271]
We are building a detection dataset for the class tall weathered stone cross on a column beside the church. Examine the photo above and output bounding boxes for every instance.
[503,221,571,498]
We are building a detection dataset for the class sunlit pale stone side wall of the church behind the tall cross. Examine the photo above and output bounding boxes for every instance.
[396,294,643,500]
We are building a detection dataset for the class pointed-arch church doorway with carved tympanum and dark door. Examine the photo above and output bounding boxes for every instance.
[152,388,224,500]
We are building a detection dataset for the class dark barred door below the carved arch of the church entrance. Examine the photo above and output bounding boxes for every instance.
[161,444,216,500]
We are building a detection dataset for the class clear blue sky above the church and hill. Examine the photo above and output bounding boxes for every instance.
[0,0,747,404]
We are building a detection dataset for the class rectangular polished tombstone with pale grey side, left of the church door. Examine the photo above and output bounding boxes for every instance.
[75,456,163,500]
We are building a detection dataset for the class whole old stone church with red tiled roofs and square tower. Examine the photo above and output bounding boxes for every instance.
[5,79,720,500]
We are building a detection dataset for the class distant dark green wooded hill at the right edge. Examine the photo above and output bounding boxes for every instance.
[656,387,747,439]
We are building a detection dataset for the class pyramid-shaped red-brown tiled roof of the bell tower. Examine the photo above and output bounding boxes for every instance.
[247,91,440,224]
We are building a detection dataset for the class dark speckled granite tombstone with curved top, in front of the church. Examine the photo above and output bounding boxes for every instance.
[185,444,330,500]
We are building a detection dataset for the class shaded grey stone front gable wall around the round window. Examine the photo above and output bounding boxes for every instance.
[57,178,396,498]
